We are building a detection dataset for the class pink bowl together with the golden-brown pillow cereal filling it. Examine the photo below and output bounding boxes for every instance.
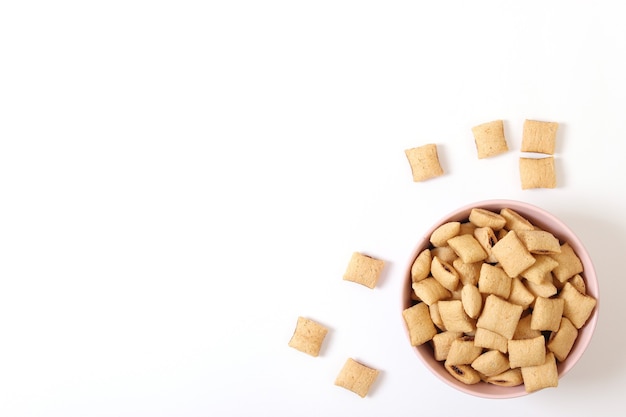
[402,200,598,398]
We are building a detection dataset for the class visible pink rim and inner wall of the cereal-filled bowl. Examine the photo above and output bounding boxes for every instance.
[402,200,600,398]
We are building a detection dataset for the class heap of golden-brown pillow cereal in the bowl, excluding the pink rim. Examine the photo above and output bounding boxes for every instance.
[403,208,597,392]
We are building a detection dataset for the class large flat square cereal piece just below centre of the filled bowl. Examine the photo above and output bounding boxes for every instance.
[476,294,524,339]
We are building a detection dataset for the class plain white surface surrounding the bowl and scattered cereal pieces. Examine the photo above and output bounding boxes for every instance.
[0,0,626,417]
